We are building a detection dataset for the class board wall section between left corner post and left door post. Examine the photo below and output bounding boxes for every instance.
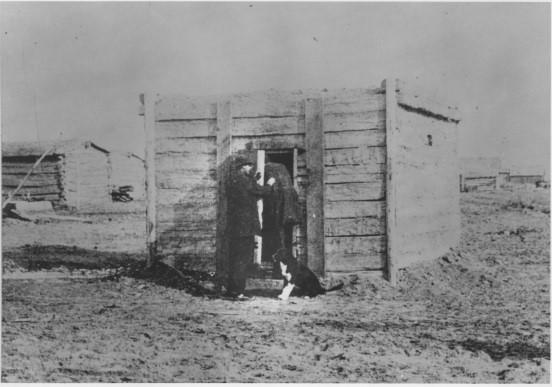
[155,119,217,270]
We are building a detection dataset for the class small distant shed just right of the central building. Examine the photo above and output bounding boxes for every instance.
[460,157,500,192]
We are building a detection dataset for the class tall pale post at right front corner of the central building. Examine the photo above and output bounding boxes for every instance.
[384,78,398,286]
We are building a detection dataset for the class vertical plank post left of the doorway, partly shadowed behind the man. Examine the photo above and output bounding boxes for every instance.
[215,101,232,287]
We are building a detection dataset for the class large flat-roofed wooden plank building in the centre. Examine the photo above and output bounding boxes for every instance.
[141,80,460,281]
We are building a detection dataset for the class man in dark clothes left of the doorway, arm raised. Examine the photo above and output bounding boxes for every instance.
[227,157,275,298]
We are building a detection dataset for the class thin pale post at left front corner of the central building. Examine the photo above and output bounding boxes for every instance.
[144,92,157,267]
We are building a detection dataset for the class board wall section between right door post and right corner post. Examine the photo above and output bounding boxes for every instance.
[324,90,386,272]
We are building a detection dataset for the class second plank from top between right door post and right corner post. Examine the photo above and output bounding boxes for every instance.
[324,110,385,133]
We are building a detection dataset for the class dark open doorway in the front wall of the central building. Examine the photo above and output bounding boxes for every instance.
[261,149,297,270]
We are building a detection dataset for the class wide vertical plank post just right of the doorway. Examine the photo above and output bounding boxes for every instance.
[305,98,325,275]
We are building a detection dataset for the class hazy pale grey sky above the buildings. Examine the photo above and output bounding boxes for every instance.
[0,2,550,173]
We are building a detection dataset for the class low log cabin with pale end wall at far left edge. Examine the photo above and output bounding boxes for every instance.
[2,140,111,211]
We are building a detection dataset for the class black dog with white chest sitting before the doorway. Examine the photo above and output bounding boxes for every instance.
[272,248,343,300]
